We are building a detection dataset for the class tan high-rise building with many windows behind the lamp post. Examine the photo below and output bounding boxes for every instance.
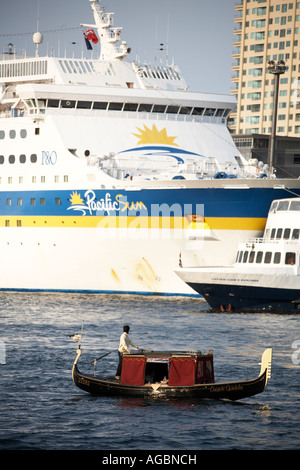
[230,0,300,137]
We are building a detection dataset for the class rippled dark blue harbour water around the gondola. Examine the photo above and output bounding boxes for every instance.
[0,293,300,452]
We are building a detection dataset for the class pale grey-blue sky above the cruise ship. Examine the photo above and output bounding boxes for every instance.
[0,0,237,94]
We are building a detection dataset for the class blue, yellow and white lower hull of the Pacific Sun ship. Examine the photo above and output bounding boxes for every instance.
[0,180,300,296]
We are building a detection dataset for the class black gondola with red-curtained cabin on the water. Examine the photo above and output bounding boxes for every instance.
[72,345,272,401]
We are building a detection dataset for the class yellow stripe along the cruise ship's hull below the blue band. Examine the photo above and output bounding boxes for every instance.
[0,216,266,231]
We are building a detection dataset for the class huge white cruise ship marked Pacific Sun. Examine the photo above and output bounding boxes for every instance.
[0,0,300,295]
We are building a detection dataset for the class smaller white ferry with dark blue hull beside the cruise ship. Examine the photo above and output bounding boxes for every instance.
[177,198,300,312]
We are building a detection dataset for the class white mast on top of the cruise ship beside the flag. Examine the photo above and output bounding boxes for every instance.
[81,0,130,60]
